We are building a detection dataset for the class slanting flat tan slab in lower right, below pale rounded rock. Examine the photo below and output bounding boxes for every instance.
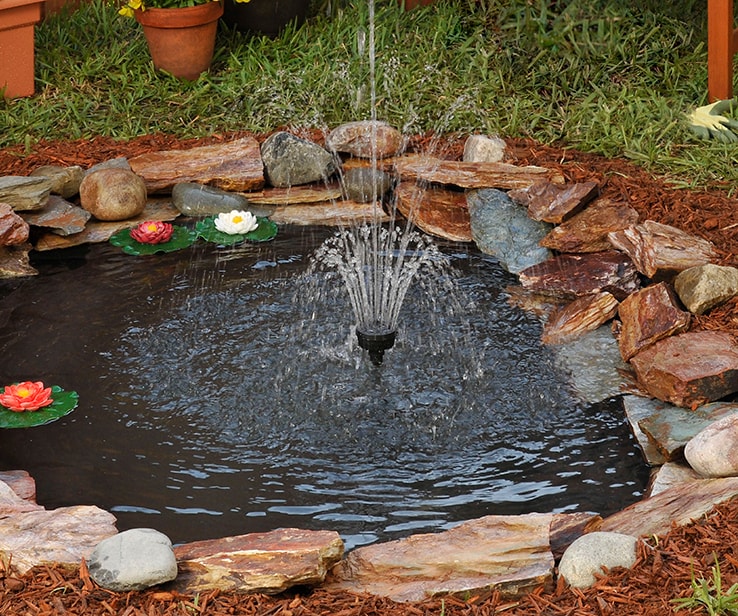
[590,477,738,537]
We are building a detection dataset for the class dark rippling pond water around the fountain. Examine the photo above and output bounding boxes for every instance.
[0,228,648,547]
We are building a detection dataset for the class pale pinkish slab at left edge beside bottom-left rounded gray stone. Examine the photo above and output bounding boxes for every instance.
[0,505,118,574]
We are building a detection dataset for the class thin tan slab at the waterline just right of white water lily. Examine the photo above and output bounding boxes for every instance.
[270,201,389,226]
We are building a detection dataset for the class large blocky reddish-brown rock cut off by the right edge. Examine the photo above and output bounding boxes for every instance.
[630,331,738,408]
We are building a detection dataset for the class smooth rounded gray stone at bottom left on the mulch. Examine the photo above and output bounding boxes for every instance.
[87,528,177,592]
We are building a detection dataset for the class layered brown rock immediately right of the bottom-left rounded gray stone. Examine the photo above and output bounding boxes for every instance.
[172,528,343,594]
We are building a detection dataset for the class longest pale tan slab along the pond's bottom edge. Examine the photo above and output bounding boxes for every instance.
[325,513,554,601]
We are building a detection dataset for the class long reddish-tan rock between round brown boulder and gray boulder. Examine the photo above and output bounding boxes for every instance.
[128,137,264,194]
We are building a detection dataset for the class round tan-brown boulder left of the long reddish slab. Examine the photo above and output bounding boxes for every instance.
[79,168,146,222]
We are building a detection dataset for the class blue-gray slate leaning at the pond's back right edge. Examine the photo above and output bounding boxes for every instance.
[466,188,551,274]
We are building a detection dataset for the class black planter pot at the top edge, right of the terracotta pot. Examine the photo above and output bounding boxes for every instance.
[223,0,310,36]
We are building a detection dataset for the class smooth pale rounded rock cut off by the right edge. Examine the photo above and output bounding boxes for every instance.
[684,413,738,477]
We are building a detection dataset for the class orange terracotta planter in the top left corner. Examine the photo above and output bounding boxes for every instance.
[0,0,43,98]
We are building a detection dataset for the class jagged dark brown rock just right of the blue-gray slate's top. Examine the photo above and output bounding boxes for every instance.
[509,182,599,225]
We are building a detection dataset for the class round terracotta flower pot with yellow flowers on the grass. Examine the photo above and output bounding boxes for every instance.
[135,2,223,81]
